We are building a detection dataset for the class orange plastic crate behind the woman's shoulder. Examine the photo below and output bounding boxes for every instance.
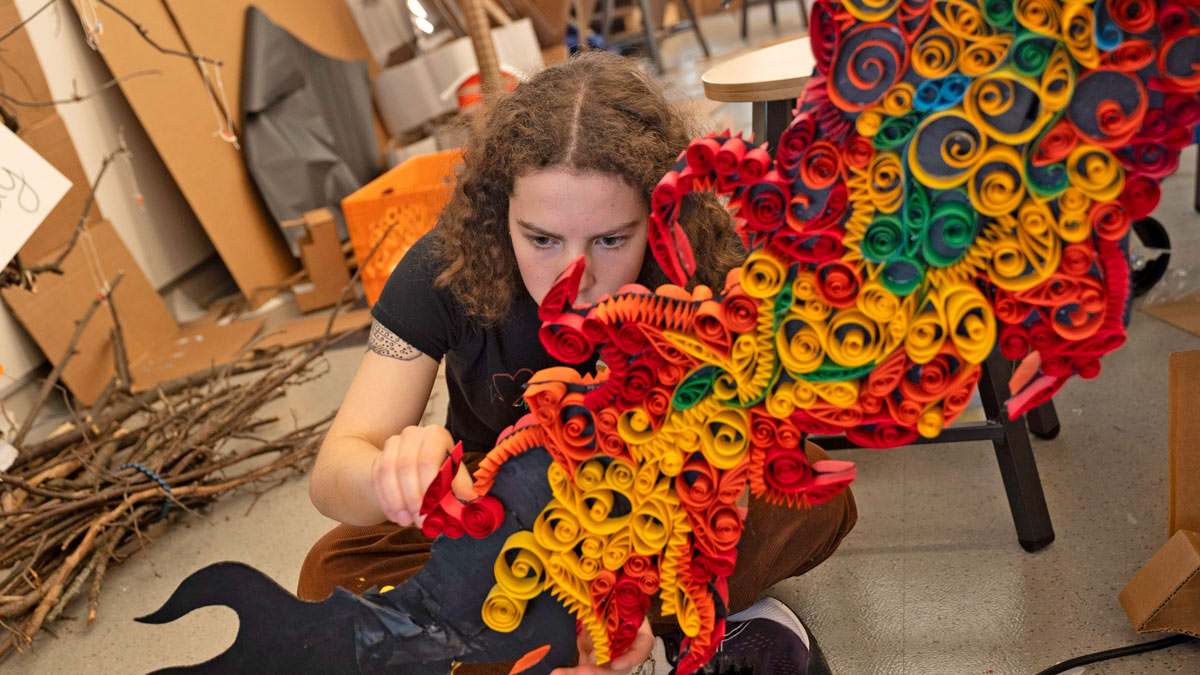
[342,150,462,305]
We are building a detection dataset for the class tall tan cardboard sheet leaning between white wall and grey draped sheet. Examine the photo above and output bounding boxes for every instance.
[81,0,296,306]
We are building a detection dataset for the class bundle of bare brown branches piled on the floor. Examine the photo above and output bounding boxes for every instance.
[0,305,355,659]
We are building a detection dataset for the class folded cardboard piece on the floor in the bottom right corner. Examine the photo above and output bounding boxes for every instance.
[1117,530,1200,637]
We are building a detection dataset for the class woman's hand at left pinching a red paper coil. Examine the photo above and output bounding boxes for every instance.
[371,426,475,527]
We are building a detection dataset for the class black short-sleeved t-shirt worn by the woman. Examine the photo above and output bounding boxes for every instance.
[371,229,595,453]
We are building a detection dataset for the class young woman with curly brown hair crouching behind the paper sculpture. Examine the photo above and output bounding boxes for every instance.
[299,53,857,675]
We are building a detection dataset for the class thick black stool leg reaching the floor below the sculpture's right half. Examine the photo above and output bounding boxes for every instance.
[979,354,1054,551]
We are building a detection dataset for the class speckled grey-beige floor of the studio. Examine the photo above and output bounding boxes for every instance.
[7,2,1200,675]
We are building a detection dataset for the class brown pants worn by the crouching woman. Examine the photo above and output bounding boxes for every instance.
[296,443,858,675]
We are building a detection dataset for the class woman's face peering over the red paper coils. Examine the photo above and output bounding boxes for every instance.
[509,167,649,304]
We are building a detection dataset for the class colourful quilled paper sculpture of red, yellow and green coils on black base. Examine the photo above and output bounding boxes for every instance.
[143,0,1200,675]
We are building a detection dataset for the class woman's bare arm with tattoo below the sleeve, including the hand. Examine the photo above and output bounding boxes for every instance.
[308,322,469,525]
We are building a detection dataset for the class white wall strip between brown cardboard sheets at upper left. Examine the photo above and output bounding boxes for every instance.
[0,0,216,398]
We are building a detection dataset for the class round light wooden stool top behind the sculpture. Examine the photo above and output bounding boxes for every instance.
[700,37,816,102]
